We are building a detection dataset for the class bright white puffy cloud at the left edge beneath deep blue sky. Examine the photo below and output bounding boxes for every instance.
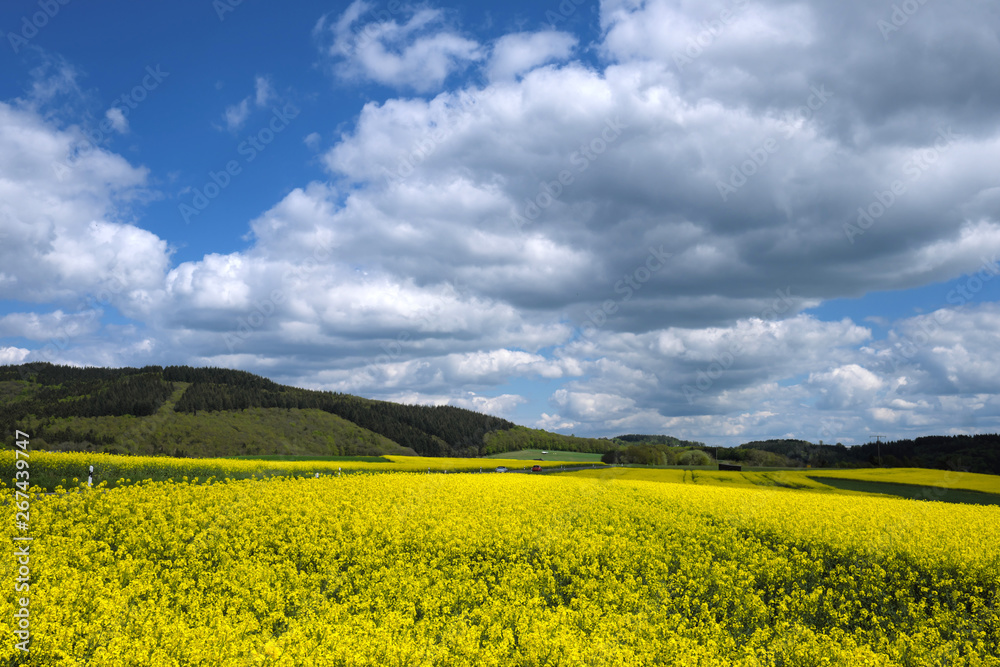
[0,102,169,307]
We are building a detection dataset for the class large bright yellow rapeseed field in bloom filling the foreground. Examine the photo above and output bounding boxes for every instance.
[0,473,1000,667]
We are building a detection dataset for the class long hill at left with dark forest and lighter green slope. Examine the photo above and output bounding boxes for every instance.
[0,363,612,457]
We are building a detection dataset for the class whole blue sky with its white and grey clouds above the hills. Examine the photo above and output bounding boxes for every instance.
[0,0,1000,445]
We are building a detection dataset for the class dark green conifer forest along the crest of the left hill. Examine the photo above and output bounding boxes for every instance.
[0,363,516,456]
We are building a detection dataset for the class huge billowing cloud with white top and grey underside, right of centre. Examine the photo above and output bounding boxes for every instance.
[316,56,1000,330]
